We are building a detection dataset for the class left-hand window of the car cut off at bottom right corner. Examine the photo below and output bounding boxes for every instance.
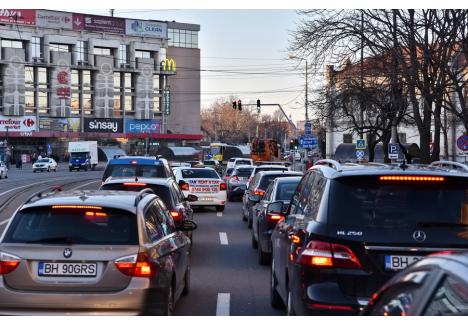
[371,283,421,316]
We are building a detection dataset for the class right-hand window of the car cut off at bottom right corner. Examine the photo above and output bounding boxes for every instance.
[424,275,468,316]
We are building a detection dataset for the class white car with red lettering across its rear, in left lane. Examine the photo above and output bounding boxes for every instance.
[173,167,227,212]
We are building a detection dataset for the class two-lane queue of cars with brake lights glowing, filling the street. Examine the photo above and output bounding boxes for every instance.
[0,156,468,316]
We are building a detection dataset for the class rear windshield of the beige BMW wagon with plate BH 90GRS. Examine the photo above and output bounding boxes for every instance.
[3,207,138,245]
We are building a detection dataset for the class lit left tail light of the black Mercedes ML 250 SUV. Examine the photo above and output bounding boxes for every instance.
[297,241,361,268]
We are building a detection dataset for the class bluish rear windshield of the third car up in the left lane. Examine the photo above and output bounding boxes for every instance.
[102,164,170,180]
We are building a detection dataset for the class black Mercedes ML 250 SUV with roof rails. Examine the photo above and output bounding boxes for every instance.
[267,160,468,315]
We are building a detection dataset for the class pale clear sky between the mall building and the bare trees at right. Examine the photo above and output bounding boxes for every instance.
[68,9,310,121]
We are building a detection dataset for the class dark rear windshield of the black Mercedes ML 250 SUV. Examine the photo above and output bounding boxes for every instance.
[328,176,468,228]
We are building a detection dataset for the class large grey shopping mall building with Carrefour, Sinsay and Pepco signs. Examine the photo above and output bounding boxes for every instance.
[0,9,202,162]
